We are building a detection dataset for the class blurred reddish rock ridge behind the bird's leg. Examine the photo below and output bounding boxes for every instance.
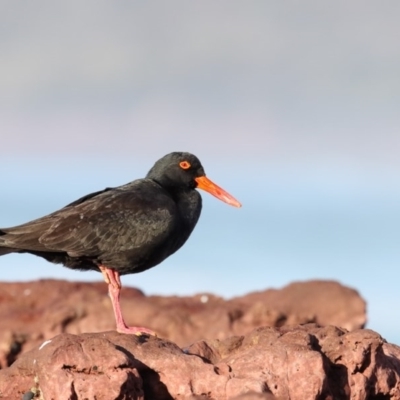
[0,280,366,368]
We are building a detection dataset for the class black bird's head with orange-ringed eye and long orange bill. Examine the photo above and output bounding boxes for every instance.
[146,152,241,207]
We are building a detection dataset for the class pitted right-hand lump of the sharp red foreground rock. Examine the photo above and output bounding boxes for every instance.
[188,324,400,400]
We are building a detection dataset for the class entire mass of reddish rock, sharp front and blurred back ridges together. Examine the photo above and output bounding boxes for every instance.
[0,280,384,400]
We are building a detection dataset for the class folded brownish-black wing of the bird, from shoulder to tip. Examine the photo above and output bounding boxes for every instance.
[0,184,176,257]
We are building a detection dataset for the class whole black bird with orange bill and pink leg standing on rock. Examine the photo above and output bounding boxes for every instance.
[0,152,241,334]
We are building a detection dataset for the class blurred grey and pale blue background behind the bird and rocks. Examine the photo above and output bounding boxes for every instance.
[0,0,400,344]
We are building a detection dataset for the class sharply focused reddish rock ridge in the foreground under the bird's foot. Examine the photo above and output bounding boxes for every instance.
[0,324,400,400]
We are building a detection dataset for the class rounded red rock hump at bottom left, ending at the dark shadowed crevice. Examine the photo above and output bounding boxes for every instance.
[0,334,143,400]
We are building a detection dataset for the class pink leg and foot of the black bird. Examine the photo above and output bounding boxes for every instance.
[99,265,156,336]
